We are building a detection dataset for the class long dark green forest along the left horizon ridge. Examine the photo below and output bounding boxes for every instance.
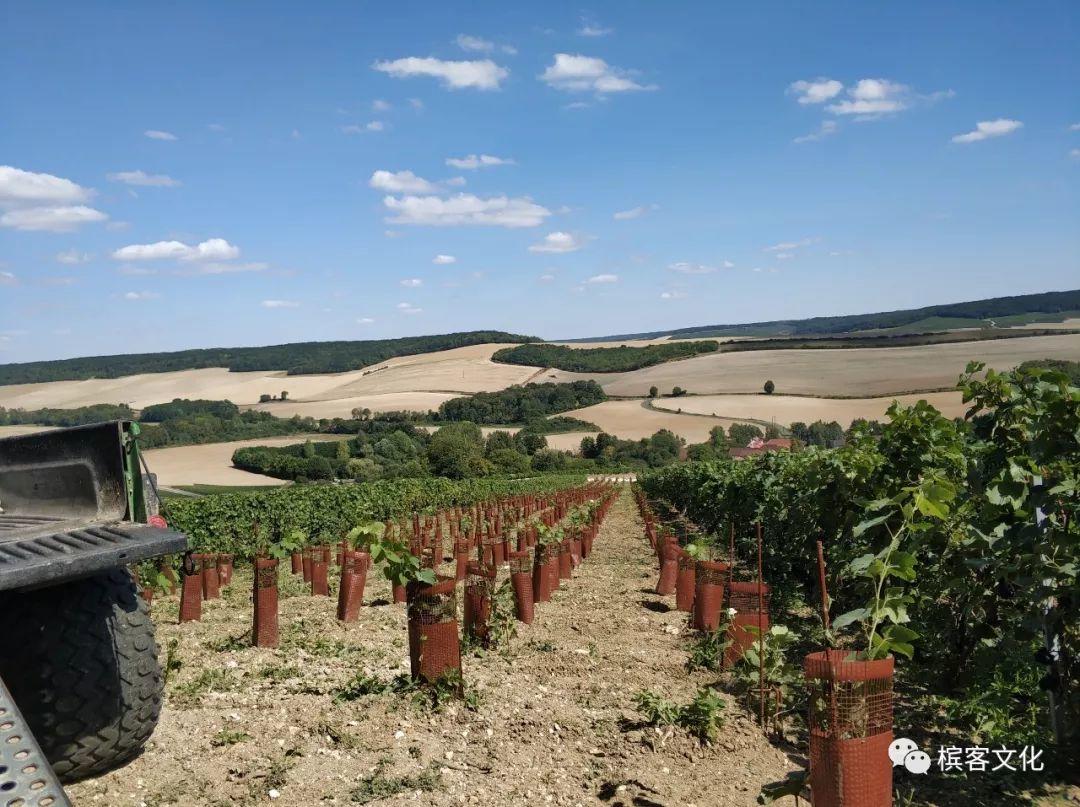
[0,331,539,385]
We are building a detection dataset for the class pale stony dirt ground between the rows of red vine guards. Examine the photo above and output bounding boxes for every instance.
[71,494,791,807]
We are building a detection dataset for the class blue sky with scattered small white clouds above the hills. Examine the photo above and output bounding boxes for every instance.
[0,0,1080,363]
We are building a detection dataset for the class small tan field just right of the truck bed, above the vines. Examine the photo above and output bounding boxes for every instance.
[144,434,352,485]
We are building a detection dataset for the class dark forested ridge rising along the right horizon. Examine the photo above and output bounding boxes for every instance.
[577,290,1080,341]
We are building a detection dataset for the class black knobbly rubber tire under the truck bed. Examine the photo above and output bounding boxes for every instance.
[0,569,162,782]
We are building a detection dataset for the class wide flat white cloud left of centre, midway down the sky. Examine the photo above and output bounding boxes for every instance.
[382,193,551,227]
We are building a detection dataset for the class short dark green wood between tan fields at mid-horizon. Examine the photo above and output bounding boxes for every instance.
[491,341,719,373]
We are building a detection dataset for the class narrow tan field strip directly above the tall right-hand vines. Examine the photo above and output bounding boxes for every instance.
[653,392,968,429]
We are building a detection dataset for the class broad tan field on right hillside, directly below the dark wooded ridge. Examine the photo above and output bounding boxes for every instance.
[544,334,1080,396]
